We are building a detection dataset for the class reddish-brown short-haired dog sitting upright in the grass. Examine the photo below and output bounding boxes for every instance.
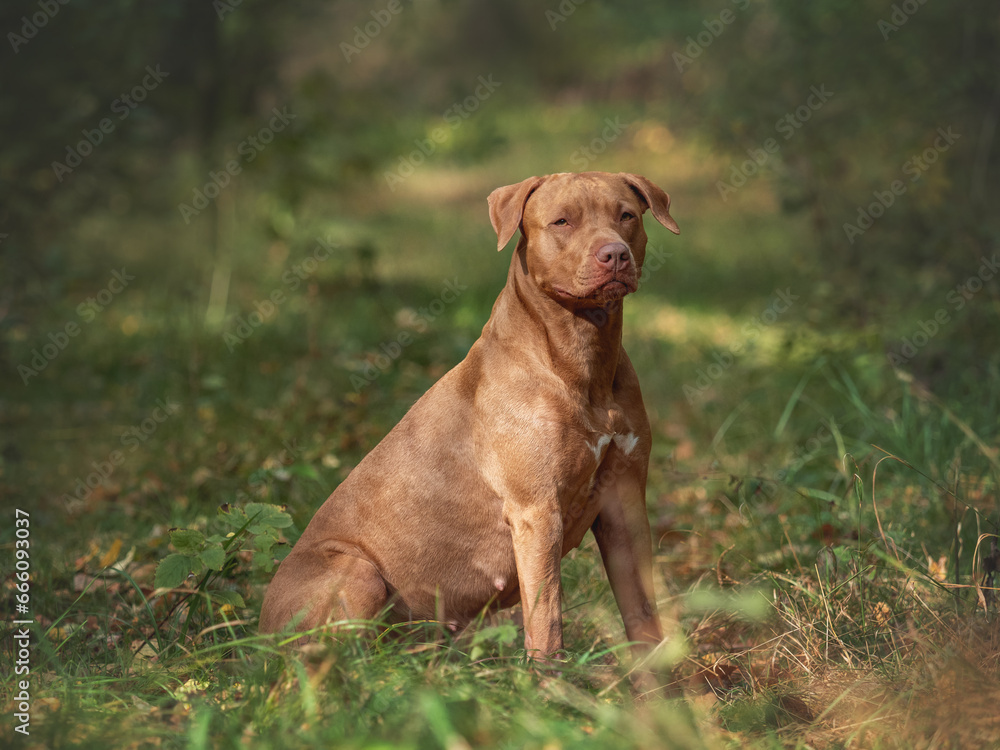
[260,172,679,656]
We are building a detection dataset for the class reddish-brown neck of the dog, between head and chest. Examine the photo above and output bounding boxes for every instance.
[483,248,622,404]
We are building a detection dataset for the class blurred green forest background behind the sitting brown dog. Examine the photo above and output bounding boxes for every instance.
[0,0,1000,747]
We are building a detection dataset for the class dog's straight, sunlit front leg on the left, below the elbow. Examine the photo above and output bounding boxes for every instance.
[506,504,563,658]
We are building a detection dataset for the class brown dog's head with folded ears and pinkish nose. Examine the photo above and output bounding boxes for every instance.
[489,172,680,308]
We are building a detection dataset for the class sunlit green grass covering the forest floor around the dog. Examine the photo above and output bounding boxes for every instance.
[0,101,1000,748]
